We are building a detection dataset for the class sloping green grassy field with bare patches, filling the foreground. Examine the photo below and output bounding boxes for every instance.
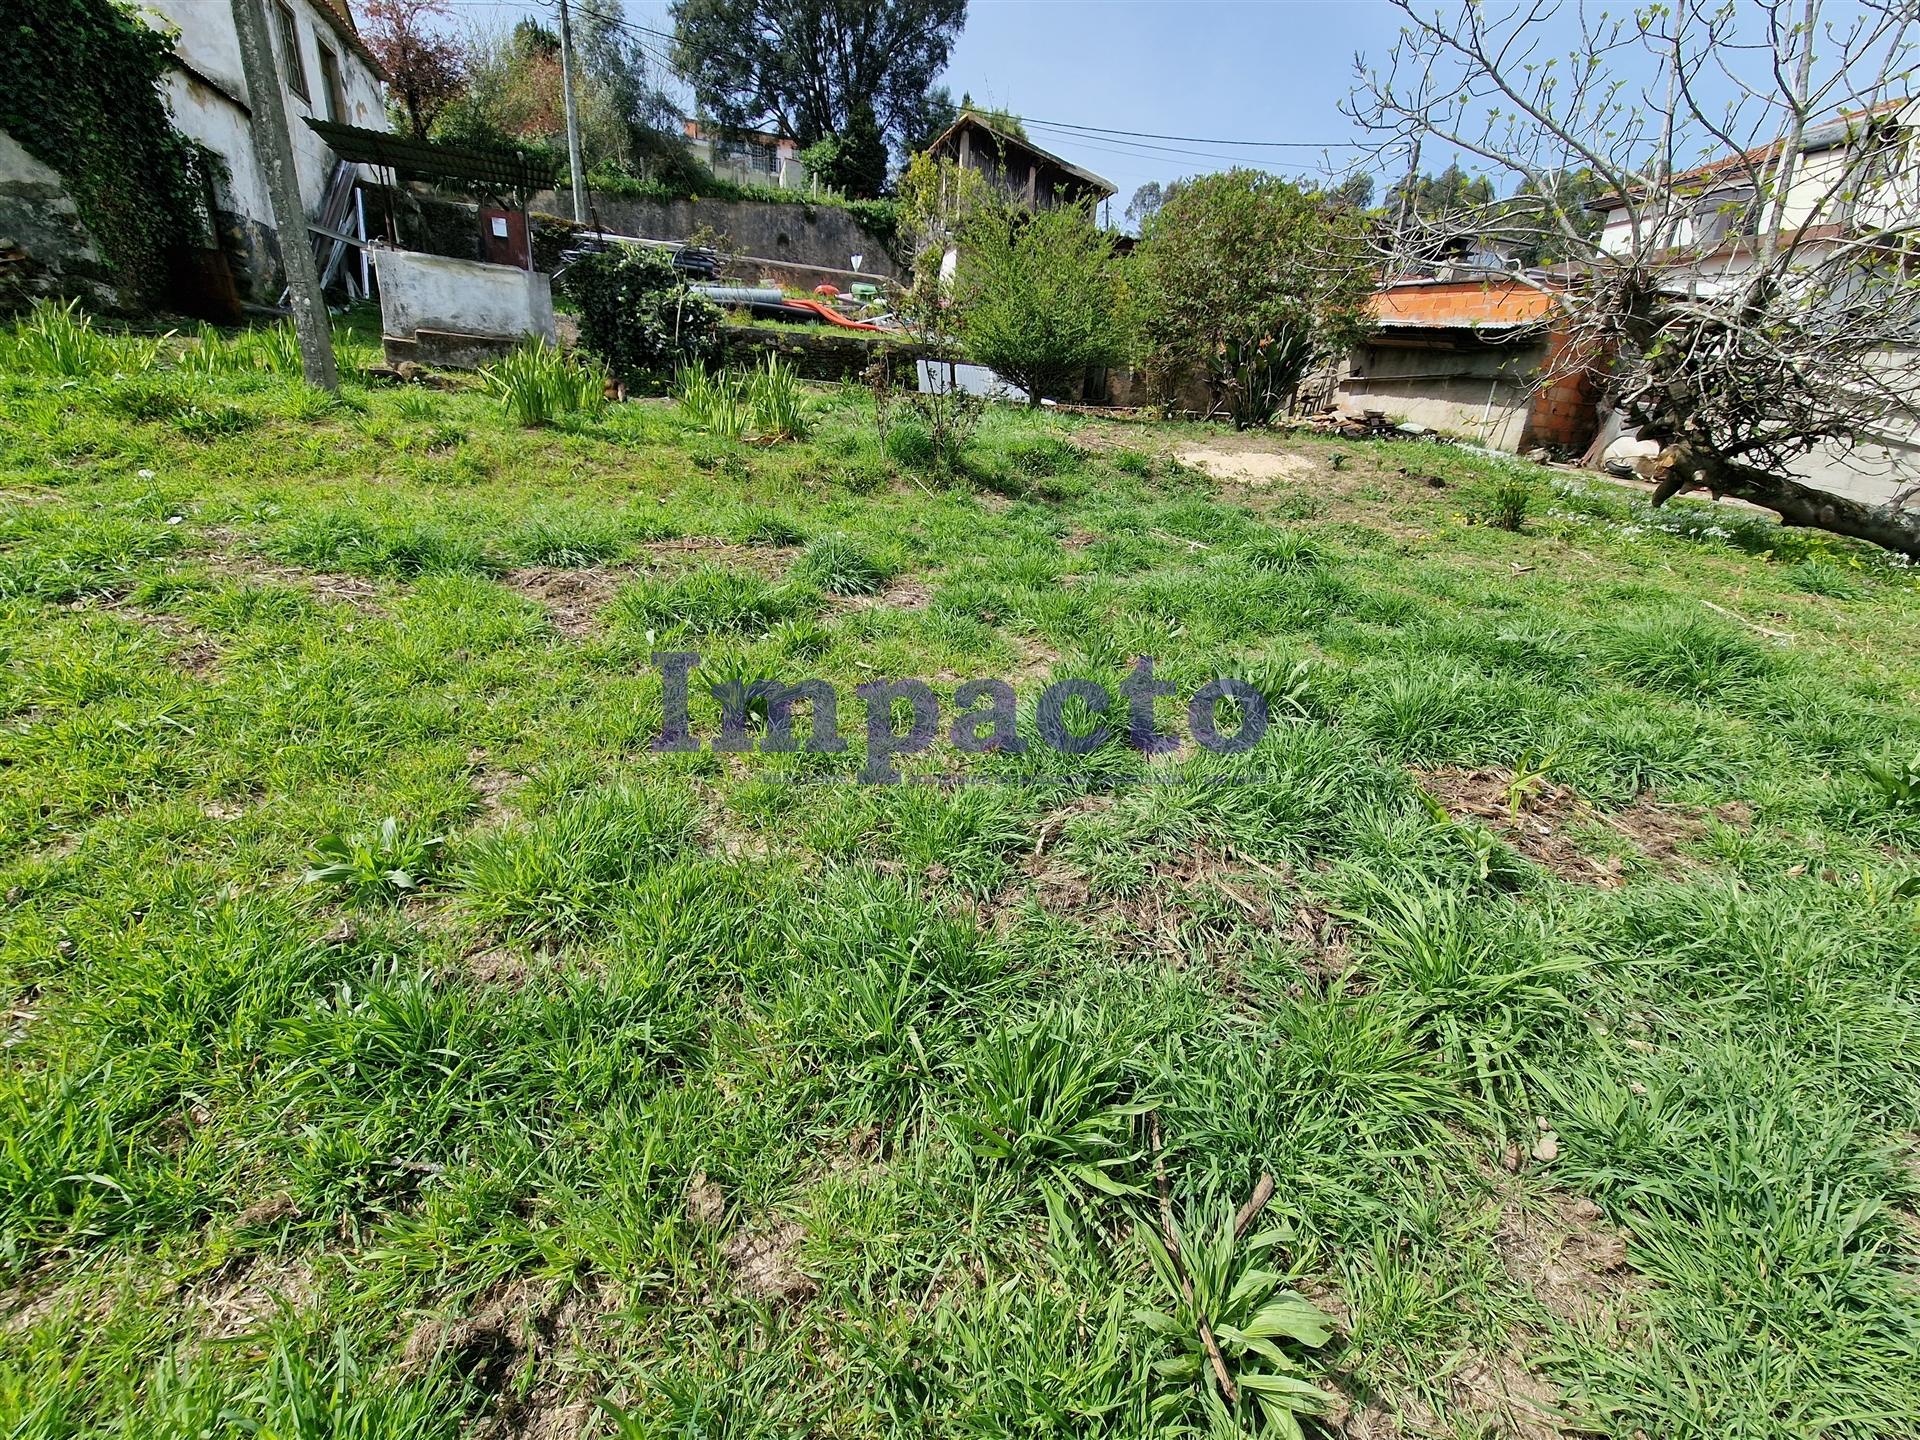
[0,307,1920,1440]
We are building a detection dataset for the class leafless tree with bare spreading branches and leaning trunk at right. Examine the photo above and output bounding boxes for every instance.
[1354,0,1920,557]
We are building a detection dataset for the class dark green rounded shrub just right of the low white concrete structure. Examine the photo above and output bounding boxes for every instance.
[561,246,720,384]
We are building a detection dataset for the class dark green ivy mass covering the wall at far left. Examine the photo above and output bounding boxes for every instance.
[0,0,204,301]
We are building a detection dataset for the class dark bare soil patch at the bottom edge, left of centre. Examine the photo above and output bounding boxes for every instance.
[399,1279,612,1440]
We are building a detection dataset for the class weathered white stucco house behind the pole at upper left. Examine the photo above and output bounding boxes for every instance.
[142,0,390,301]
